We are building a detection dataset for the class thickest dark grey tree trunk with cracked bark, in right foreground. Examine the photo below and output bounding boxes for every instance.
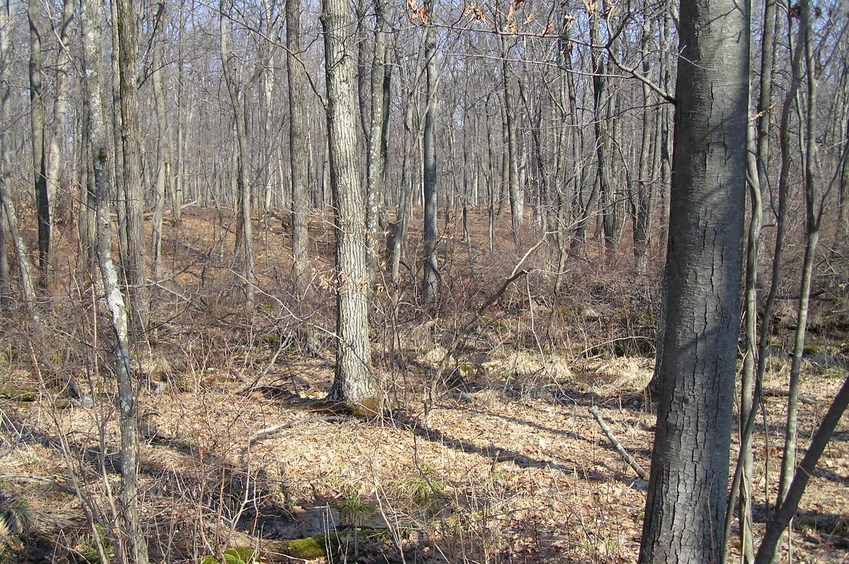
[640,0,749,563]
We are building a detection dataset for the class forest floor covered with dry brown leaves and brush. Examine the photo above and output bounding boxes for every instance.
[0,205,849,563]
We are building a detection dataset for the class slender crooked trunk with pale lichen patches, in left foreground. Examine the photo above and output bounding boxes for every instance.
[82,0,148,564]
